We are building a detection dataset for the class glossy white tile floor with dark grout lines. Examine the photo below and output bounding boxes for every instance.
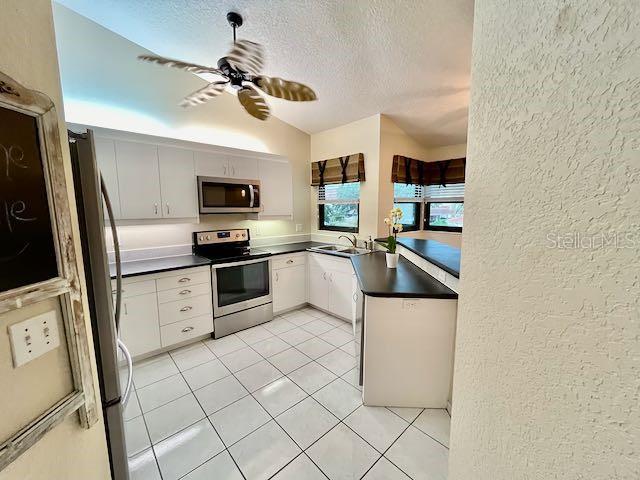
[125,308,450,480]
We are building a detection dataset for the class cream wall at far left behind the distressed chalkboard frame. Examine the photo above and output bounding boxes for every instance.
[0,0,110,480]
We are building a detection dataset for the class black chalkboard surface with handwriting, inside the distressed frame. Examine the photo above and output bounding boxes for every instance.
[0,107,59,292]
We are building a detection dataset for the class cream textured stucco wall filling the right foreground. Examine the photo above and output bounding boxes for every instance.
[449,0,640,480]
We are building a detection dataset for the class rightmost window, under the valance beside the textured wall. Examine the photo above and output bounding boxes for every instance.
[424,183,464,232]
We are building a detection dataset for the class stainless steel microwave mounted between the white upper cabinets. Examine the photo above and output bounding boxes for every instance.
[198,177,261,213]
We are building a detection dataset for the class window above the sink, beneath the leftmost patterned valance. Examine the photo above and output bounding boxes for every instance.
[318,182,360,233]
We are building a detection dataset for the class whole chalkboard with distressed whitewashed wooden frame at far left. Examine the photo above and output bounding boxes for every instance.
[0,72,100,471]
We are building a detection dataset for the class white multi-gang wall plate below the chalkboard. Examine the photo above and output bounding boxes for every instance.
[9,311,60,368]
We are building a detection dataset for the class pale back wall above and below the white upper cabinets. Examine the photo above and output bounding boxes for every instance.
[54,3,311,249]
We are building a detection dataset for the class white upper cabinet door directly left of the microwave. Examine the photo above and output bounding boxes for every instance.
[158,147,198,218]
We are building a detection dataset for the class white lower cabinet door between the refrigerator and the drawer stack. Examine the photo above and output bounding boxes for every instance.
[120,292,160,357]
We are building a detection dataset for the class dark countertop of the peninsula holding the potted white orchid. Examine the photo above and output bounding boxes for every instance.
[351,252,458,299]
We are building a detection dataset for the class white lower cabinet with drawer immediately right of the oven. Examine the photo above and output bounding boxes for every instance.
[271,253,307,313]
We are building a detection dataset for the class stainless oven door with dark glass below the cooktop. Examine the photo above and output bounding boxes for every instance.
[211,258,273,317]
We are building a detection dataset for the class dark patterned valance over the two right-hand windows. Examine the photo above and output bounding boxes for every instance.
[391,155,467,186]
